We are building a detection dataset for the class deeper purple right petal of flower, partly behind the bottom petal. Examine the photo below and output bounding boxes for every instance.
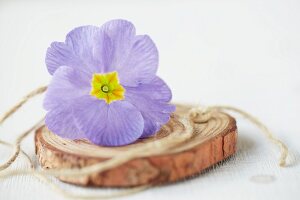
[125,77,175,137]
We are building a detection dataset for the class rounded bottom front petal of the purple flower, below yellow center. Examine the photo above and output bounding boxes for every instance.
[74,96,144,146]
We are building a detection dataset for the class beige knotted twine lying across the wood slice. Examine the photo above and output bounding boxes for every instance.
[0,86,288,199]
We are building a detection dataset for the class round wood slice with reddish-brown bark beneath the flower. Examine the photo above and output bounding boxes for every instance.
[35,106,237,187]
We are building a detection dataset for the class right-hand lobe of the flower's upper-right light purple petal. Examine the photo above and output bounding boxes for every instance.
[119,35,158,86]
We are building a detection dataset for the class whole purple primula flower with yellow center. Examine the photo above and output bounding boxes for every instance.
[44,20,175,146]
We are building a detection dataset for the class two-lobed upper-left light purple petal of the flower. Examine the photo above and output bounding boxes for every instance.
[46,26,113,74]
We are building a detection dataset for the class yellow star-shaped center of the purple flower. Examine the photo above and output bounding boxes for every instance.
[90,72,125,104]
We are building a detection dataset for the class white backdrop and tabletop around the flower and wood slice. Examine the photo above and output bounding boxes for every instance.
[0,0,300,200]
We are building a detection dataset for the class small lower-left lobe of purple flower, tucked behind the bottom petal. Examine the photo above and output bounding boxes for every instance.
[45,104,85,139]
